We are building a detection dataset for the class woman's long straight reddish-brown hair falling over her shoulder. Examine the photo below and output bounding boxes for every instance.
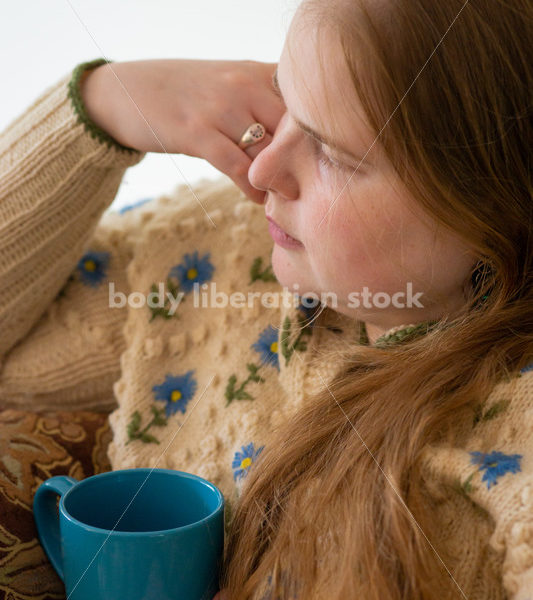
[221,0,533,600]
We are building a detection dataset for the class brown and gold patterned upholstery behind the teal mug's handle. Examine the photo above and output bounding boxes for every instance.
[0,409,112,600]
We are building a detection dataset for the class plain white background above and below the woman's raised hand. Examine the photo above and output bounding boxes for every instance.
[0,0,300,209]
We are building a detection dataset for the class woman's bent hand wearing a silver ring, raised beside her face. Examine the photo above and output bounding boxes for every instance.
[81,59,285,203]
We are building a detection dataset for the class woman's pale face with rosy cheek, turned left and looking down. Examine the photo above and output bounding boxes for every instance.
[248,12,475,340]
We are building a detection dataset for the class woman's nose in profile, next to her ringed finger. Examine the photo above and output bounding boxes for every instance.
[248,119,298,200]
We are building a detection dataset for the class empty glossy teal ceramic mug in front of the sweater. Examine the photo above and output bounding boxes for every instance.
[33,469,224,600]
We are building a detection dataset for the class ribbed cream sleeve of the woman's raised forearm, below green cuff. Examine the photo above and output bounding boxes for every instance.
[0,59,144,368]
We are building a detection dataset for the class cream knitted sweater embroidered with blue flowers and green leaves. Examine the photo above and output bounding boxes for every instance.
[0,61,533,600]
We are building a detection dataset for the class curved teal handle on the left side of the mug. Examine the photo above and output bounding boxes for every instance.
[33,475,78,582]
